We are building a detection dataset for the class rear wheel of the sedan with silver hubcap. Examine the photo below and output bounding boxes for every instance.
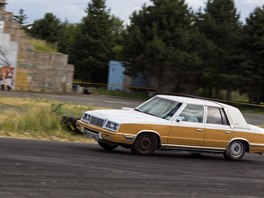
[224,141,246,161]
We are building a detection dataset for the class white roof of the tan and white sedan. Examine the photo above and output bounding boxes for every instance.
[157,95,225,108]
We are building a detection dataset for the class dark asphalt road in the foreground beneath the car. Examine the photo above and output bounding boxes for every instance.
[0,138,264,198]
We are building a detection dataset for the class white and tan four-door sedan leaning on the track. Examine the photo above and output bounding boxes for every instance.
[77,95,264,160]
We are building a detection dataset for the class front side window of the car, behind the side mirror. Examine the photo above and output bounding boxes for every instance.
[179,104,204,123]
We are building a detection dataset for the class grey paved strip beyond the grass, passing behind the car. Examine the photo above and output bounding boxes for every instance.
[0,91,264,126]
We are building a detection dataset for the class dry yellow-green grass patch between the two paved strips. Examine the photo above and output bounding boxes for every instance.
[0,97,94,142]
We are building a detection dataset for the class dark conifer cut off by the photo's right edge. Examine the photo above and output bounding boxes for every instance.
[240,6,264,104]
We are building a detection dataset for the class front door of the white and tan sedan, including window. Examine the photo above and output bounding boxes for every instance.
[167,104,205,147]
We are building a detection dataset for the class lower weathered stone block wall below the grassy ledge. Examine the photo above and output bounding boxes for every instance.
[17,52,73,92]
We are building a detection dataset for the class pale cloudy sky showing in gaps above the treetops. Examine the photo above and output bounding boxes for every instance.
[6,0,264,24]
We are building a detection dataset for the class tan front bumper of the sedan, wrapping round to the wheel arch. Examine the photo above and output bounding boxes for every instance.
[76,120,135,145]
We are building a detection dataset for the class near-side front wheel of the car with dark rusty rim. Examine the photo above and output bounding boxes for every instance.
[131,133,158,155]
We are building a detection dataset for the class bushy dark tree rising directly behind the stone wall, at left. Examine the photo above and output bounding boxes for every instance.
[29,13,61,43]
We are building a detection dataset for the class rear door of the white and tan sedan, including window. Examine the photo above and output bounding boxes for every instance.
[204,106,233,148]
